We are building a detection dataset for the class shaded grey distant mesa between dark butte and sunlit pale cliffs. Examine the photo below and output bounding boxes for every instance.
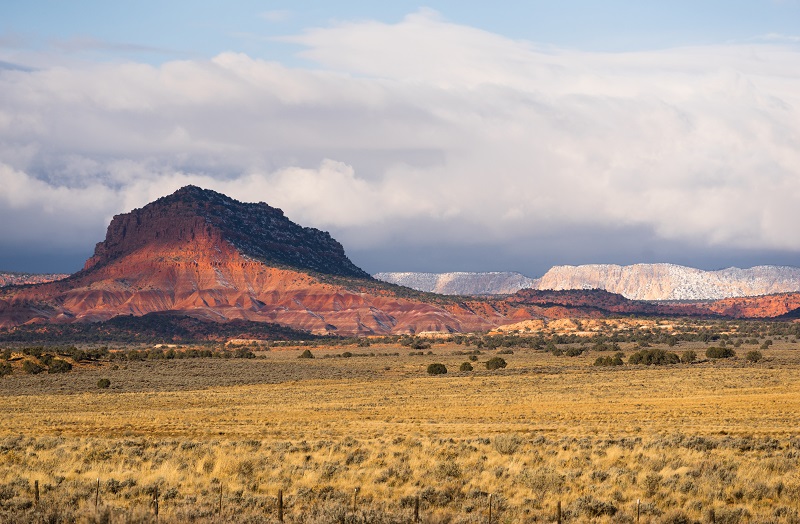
[372,272,538,295]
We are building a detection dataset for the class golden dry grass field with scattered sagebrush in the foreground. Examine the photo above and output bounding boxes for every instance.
[0,340,800,523]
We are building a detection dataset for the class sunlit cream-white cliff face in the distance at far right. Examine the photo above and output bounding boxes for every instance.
[539,264,800,300]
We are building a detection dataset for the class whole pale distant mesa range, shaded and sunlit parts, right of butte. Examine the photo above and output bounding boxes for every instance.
[374,264,800,300]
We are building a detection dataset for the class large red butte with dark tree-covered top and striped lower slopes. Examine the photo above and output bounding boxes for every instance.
[0,186,507,335]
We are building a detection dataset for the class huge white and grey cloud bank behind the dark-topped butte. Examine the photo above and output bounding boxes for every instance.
[0,10,800,270]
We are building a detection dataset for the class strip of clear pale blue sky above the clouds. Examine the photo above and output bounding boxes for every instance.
[6,0,800,63]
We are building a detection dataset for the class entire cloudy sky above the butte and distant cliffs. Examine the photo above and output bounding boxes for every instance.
[0,0,800,276]
